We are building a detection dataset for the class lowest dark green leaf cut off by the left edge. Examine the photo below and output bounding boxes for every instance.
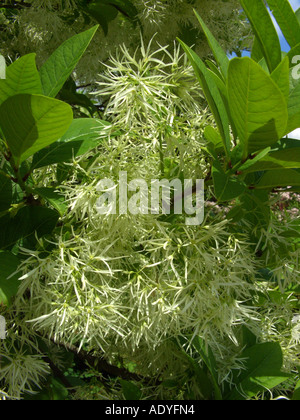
[0,252,20,306]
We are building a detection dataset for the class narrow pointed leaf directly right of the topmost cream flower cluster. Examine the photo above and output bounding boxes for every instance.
[179,40,231,155]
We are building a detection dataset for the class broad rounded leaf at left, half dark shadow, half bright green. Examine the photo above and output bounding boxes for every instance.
[0,94,73,166]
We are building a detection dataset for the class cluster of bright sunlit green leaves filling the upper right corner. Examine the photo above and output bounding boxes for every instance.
[181,0,300,207]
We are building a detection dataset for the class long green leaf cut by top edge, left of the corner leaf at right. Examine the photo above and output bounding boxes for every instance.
[240,0,281,73]
